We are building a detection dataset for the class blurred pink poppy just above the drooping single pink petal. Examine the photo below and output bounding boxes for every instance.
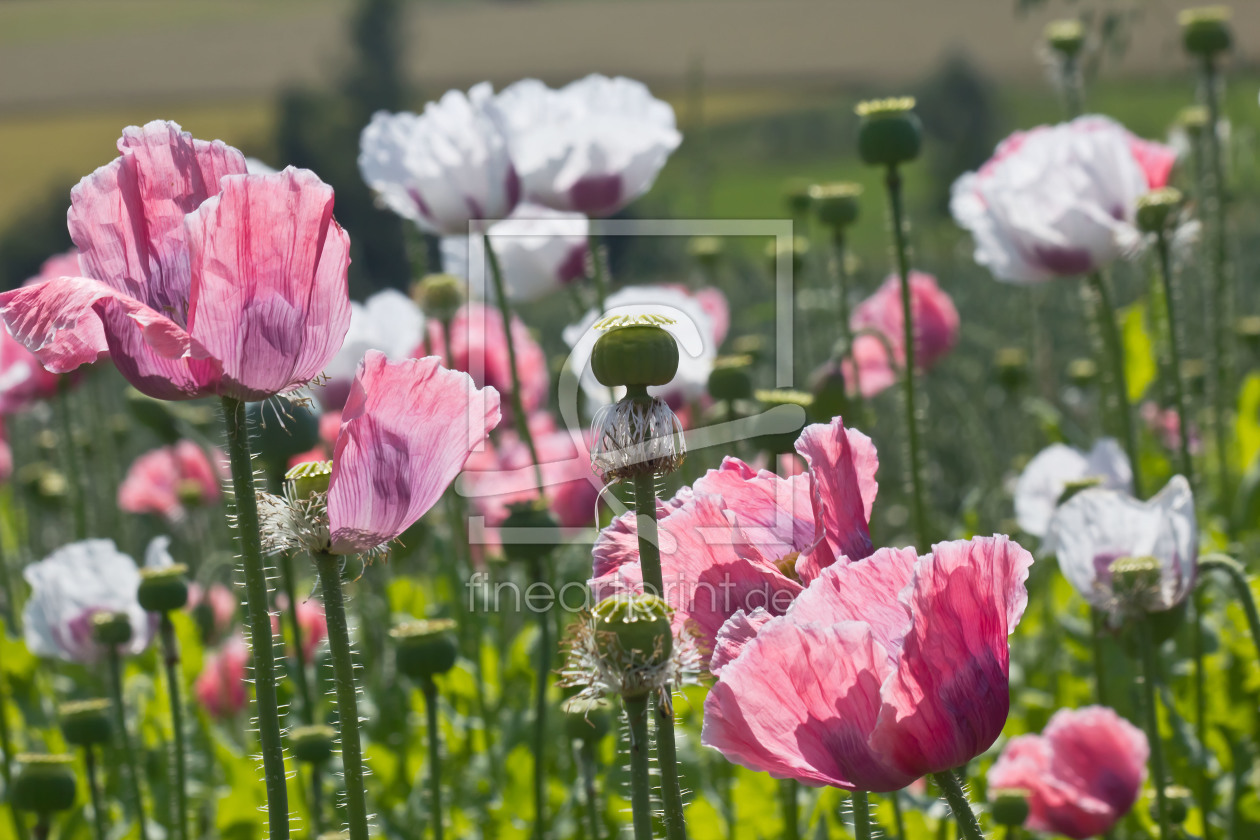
[416,301,551,414]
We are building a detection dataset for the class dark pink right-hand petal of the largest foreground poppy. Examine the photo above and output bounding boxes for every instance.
[871,536,1032,777]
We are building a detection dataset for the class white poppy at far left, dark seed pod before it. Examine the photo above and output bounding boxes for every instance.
[21,538,164,665]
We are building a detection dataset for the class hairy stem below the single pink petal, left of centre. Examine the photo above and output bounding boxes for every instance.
[315,552,368,840]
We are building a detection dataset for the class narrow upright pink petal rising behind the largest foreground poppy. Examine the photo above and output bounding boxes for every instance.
[796,417,879,583]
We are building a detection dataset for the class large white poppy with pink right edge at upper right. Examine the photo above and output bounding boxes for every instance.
[950,116,1176,283]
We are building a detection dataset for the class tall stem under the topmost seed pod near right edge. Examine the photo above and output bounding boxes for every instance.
[1200,55,1232,511]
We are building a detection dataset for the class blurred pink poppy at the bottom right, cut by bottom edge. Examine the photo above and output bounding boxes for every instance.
[988,705,1150,840]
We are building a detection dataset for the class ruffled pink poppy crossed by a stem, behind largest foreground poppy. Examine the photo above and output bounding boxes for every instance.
[591,417,879,649]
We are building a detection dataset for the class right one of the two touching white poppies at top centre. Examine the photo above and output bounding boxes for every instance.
[495,73,683,217]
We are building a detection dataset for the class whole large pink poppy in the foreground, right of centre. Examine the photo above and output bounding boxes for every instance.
[701,536,1032,791]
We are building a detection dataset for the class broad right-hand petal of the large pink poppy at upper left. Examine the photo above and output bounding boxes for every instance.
[185,167,350,399]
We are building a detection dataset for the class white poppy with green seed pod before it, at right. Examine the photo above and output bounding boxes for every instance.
[1046,476,1198,613]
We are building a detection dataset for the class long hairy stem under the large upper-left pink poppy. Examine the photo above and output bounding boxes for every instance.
[223,397,289,840]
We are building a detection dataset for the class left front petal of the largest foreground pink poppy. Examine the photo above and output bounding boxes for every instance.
[701,618,915,791]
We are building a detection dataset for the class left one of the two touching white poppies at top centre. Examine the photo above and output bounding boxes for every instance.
[359,82,520,234]
